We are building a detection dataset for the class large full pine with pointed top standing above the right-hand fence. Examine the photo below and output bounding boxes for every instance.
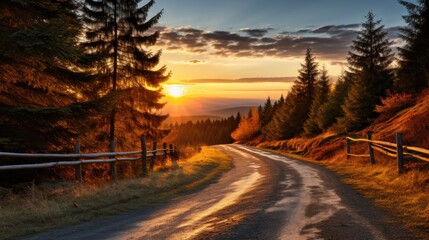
[343,12,394,130]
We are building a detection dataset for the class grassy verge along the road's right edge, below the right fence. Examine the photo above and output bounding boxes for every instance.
[260,146,429,239]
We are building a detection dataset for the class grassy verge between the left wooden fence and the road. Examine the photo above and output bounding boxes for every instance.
[0,148,233,239]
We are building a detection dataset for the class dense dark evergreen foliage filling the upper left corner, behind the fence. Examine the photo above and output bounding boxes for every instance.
[0,0,104,151]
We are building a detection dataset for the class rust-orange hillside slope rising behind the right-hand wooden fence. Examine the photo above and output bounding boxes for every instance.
[259,89,429,160]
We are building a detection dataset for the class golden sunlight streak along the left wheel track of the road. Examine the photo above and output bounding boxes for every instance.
[115,146,261,239]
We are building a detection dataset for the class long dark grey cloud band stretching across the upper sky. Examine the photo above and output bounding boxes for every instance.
[158,24,399,63]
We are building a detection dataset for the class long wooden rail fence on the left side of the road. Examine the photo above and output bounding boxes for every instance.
[0,137,179,182]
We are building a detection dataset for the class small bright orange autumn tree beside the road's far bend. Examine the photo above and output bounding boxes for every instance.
[231,108,261,142]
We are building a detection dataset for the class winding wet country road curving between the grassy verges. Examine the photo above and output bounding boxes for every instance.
[26,145,412,240]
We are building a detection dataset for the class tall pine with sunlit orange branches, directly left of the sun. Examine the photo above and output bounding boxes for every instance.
[83,0,169,145]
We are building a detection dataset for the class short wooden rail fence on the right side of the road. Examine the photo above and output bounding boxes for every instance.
[346,133,429,173]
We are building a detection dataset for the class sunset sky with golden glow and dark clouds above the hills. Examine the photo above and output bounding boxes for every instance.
[143,0,416,114]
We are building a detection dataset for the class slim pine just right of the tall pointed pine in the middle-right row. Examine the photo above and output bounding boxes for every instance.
[304,66,330,136]
